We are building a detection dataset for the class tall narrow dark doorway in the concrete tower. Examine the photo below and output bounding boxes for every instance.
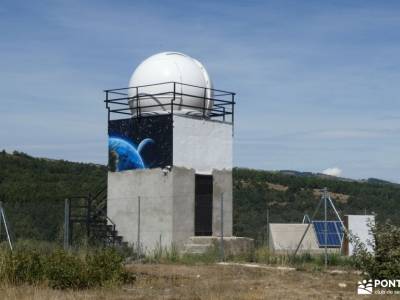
[194,175,213,236]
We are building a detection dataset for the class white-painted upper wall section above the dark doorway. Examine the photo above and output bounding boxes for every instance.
[173,115,233,174]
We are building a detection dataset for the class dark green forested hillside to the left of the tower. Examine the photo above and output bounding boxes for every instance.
[0,151,107,241]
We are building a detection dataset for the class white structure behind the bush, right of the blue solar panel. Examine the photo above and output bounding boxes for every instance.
[344,215,375,255]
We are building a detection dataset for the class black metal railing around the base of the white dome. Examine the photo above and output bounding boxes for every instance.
[104,82,235,124]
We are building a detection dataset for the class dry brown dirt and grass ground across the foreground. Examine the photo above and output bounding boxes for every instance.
[0,265,394,300]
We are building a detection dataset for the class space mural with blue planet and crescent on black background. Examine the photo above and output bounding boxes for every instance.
[108,115,172,172]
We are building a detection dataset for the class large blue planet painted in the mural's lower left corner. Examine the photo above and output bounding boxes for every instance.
[108,137,145,171]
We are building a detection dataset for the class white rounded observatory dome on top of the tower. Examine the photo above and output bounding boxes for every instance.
[128,52,213,115]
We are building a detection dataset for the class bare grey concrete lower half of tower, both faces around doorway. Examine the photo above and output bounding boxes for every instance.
[107,167,232,252]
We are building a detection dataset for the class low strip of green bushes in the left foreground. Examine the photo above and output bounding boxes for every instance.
[0,249,135,289]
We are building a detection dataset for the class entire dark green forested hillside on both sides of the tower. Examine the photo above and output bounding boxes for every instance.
[0,151,400,245]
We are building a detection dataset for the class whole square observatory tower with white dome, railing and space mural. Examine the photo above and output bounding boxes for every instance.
[105,52,244,251]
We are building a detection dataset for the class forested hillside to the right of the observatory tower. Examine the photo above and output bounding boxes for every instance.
[233,168,400,241]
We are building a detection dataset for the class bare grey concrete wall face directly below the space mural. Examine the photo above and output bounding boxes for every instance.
[107,169,173,251]
